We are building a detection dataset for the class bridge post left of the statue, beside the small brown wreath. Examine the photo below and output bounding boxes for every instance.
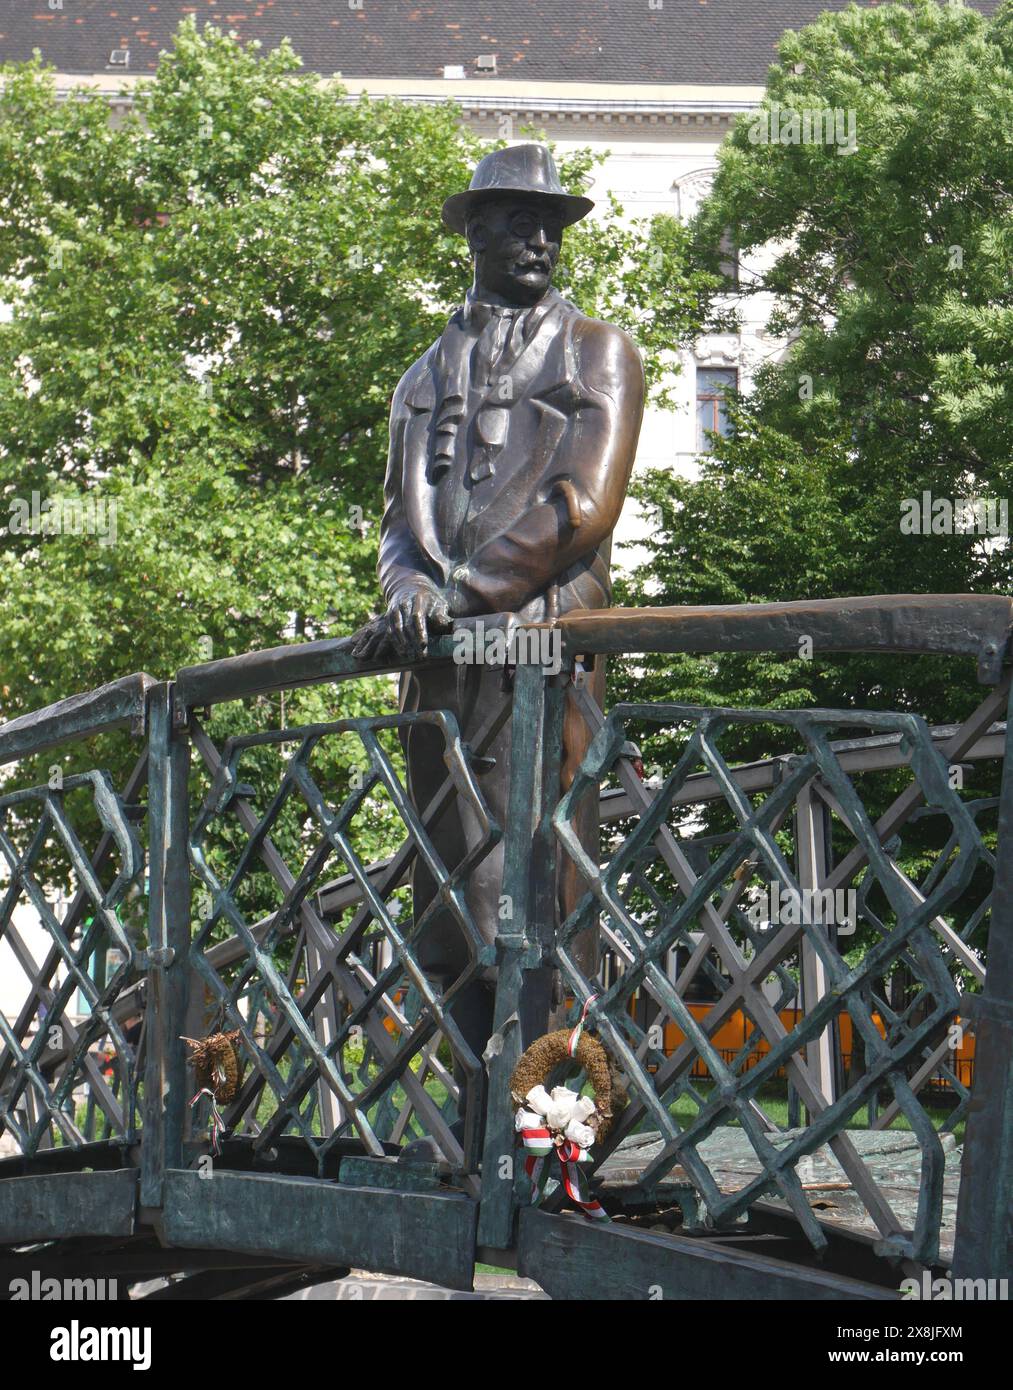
[140,681,190,1207]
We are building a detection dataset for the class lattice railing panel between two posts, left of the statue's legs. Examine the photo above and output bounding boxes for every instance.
[190,713,497,1173]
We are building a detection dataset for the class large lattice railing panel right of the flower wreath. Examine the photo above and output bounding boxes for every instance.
[554,705,994,1262]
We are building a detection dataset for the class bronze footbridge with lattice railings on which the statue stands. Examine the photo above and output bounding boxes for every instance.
[0,596,1013,1300]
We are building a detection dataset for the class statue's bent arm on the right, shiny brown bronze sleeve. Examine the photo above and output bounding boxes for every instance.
[447,320,645,617]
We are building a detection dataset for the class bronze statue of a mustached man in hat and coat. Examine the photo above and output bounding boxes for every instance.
[356,145,643,1100]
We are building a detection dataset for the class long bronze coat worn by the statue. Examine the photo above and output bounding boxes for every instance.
[378,291,643,976]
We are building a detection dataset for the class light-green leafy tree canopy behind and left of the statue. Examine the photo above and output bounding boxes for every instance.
[0,21,709,717]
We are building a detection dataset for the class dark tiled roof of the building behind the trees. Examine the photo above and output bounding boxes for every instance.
[0,0,999,85]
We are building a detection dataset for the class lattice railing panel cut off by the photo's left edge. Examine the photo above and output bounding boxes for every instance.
[0,771,145,1156]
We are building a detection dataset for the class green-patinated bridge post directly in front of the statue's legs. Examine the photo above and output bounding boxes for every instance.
[478,663,566,1250]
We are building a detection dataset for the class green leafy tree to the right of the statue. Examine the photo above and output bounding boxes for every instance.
[624,0,1013,721]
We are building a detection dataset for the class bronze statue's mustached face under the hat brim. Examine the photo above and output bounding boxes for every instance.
[468,199,563,304]
